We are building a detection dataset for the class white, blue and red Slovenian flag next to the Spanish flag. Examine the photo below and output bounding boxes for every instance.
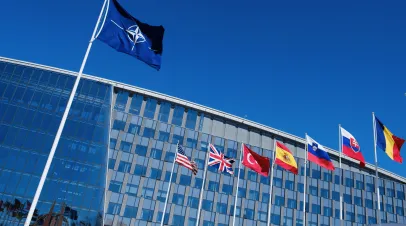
[306,135,335,170]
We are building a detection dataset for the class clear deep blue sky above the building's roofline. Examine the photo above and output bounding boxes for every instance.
[0,0,406,176]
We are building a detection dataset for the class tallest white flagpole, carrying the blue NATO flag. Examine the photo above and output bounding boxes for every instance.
[24,0,107,226]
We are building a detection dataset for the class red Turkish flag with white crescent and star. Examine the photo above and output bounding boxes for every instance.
[242,144,270,177]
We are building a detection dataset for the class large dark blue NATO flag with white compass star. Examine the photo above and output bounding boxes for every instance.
[97,0,165,70]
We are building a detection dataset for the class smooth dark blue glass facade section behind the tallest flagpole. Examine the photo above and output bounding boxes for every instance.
[0,61,112,225]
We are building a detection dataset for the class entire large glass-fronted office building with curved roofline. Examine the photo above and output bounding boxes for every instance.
[0,58,406,226]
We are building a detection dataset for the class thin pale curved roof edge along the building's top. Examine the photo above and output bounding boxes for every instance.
[0,56,406,184]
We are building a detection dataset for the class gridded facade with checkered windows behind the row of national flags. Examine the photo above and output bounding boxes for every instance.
[105,88,405,226]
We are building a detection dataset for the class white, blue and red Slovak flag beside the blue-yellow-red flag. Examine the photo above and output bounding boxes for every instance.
[341,128,365,167]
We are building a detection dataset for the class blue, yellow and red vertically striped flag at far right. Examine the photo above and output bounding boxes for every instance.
[375,117,405,163]
